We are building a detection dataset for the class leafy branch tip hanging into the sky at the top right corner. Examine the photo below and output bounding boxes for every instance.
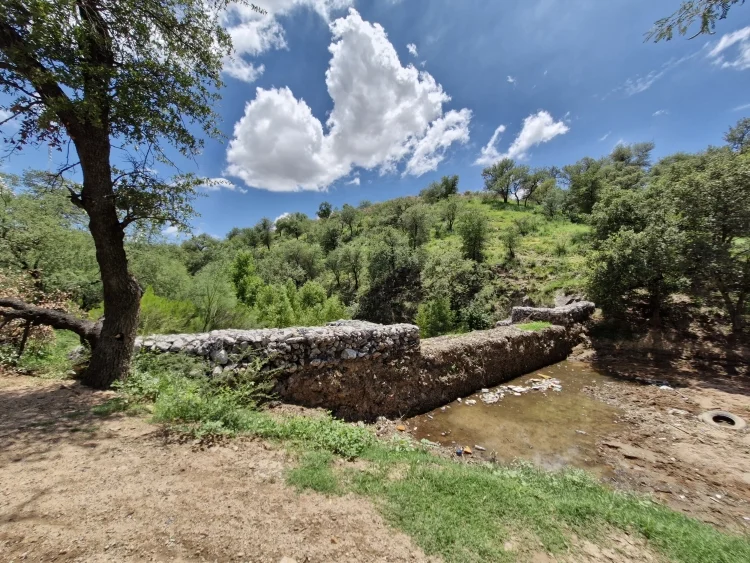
[646,0,745,43]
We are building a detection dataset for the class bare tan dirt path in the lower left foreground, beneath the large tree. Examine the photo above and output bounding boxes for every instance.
[0,375,438,563]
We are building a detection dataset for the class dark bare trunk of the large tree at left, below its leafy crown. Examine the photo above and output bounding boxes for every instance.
[76,132,141,389]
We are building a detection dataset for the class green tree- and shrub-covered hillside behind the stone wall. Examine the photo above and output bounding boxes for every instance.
[0,119,750,362]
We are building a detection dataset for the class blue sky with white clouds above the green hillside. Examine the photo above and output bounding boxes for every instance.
[3,0,750,236]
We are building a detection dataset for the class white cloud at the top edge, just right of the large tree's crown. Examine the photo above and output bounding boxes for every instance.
[221,0,354,82]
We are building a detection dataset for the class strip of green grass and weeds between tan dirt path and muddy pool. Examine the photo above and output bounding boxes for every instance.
[85,352,750,563]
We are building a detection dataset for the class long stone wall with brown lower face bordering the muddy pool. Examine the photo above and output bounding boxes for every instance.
[137,321,582,420]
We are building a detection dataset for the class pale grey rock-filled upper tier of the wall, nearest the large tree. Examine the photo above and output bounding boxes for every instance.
[136,321,419,373]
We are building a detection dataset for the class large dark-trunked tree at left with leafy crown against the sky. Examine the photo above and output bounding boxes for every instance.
[0,0,250,388]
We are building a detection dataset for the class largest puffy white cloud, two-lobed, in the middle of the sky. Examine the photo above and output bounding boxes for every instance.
[227,9,471,192]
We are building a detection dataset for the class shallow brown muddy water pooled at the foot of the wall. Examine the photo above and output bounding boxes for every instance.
[407,361,620,477]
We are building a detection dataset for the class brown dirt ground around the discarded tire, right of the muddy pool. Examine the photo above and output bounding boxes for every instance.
[587,354,750,532]
